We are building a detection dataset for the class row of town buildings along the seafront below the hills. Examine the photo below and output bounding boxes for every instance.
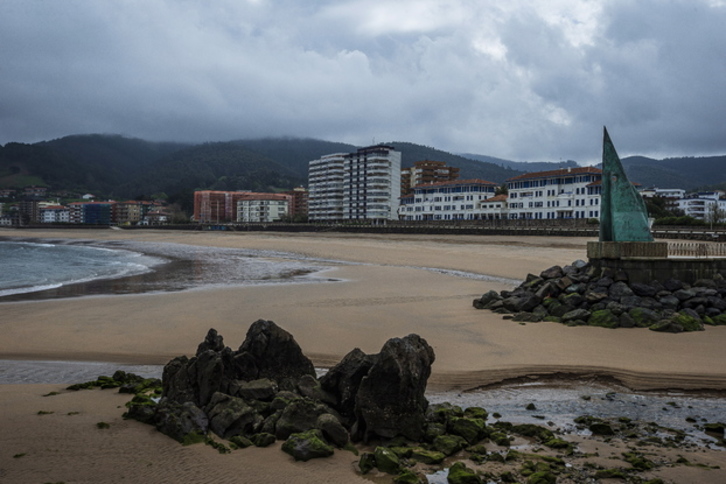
[0,144,726,226]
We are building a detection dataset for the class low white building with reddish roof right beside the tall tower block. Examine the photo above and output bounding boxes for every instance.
[399,179,497,220]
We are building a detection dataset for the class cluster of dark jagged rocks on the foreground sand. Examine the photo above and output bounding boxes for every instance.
[126,320,435,460]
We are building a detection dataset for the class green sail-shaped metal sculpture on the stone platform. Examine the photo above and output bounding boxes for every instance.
[600,128,653,242]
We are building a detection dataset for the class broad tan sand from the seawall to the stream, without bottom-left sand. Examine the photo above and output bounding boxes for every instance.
[0,230,726,390]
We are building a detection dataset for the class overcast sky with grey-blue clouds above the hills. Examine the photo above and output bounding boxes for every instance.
[0,0,726,163]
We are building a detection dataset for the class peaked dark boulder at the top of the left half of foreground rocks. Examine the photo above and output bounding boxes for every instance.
[233,319,315,389]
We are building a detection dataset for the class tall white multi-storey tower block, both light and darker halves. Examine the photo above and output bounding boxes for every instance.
[308,145,401,221]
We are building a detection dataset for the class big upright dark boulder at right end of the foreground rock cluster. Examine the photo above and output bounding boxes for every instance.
[353,334,435,441]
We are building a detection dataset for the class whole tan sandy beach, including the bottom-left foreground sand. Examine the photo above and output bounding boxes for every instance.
[0,229,726,482]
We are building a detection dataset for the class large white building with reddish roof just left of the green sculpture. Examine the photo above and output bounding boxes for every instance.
[507,166,602,219]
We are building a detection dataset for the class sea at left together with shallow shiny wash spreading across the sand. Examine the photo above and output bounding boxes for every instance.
[0,239,330,302]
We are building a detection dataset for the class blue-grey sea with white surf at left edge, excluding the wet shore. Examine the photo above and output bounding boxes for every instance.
[0,241,164,297]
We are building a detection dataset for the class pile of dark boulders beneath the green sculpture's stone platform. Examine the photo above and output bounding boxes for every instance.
[473,260,726,333]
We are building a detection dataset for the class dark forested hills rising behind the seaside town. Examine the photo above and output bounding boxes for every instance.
[0,135,726,208]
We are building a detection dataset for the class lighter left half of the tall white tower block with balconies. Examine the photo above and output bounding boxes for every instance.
[308,153,346,220]
